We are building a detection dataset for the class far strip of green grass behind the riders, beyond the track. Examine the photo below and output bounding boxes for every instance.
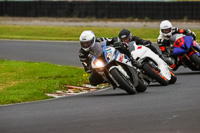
[0,25,159,41]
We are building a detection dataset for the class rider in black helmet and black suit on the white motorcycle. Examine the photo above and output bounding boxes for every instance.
[108,29,172,65]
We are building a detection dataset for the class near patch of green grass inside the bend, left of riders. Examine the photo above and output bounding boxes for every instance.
[0,60,88,105]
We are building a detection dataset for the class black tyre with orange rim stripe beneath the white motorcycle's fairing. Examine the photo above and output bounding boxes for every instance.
[142,63,169,86]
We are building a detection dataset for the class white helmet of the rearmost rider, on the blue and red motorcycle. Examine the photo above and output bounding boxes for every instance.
[160,20,172,37]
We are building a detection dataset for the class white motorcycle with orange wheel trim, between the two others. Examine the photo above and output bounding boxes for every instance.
[129,42,177,86]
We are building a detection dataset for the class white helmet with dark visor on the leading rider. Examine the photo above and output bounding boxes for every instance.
[79,30,95,51]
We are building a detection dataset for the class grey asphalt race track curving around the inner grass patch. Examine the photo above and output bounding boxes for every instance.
[0,40,200,133]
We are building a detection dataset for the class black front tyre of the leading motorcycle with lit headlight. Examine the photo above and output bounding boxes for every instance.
[110,68,137,95]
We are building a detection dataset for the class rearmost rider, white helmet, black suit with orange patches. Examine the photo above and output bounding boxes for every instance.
[157,20,196,70]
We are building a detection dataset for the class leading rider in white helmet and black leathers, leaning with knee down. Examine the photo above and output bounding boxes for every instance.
[79,30,106,86]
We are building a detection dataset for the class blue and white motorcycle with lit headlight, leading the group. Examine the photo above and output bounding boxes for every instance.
[91,42,147,94]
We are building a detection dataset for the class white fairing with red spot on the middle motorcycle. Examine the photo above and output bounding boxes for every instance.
[131,43,171,80]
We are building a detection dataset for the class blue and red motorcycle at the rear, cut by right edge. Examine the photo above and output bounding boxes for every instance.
[161,34,200,71]
